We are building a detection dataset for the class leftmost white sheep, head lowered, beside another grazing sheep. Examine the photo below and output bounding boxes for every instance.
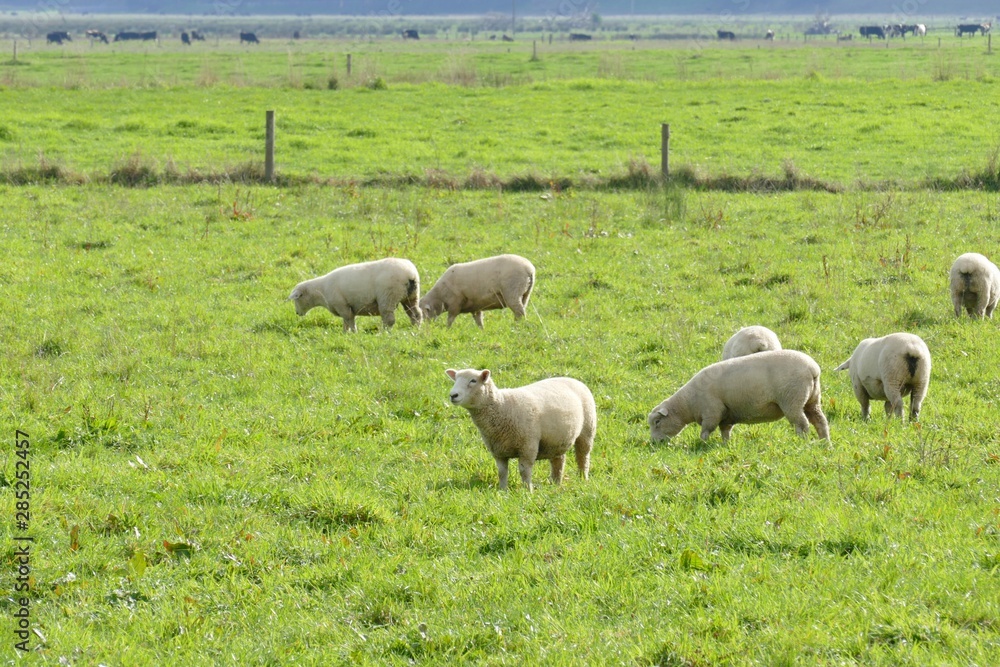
[287,257,422,331]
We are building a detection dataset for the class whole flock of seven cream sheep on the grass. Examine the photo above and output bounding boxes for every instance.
[288,253,1000,490]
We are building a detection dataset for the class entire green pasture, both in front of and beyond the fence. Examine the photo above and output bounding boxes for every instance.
[0,18,1000,666]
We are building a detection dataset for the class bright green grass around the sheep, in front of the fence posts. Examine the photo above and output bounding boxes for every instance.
[0,185,1000,665]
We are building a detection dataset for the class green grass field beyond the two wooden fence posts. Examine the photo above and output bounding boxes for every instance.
[0,37,1000,188]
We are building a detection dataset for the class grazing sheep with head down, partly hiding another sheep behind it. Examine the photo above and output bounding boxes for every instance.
[647,350,830,442]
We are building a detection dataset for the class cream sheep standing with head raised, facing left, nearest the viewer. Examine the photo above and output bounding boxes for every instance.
[445,368,597,491]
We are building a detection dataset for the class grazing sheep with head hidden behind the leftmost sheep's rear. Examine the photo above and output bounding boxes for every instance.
[420,255,535,329]
